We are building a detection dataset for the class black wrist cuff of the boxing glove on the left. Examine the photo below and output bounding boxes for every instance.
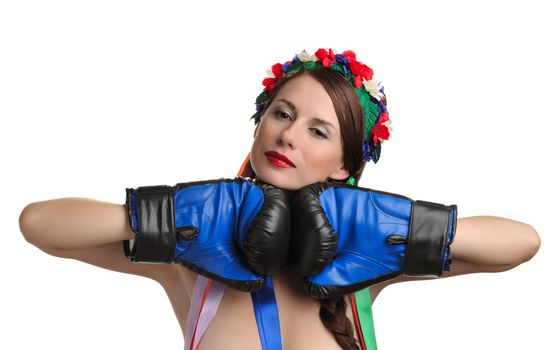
[123,185,176,263]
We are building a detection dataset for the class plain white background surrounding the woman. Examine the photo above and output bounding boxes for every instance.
[0,0,556,350]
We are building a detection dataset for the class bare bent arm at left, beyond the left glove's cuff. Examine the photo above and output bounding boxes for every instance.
[19,197,180,283]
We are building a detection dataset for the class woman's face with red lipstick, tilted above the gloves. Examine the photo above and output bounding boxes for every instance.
[250,74,349,190]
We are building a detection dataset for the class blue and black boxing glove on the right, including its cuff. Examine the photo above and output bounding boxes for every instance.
[290,182,457,299]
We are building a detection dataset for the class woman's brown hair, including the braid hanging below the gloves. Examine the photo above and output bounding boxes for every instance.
[253,68,366,350]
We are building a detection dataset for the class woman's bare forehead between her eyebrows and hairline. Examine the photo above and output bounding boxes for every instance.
[274,74,338,125]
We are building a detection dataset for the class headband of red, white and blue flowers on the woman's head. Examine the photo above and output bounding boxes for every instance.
[251,49,393,164]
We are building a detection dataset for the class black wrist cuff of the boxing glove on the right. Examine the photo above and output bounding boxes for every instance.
[403,200,457,277]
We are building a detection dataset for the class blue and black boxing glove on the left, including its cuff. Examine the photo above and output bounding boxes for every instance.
[123,177,291,292]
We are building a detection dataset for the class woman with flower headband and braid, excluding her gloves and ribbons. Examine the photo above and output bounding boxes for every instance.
[20,49,540,349]
